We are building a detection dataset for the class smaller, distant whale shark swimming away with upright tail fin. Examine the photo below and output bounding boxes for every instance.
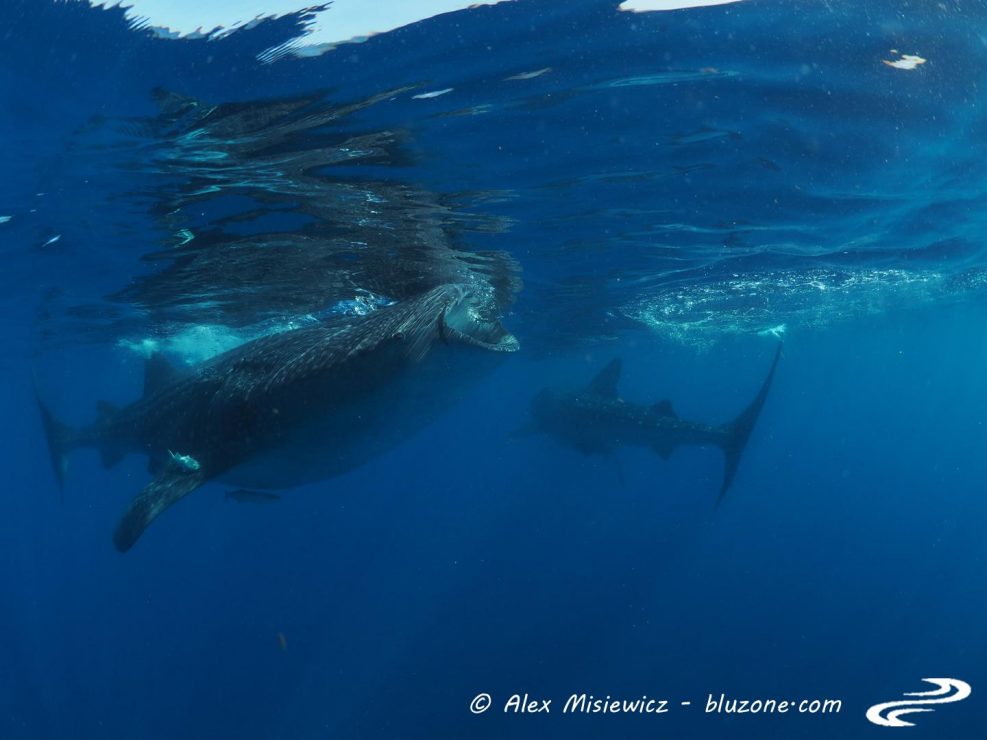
[521,343,782,505]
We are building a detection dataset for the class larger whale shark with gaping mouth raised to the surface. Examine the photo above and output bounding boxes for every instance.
[39,283,518,552]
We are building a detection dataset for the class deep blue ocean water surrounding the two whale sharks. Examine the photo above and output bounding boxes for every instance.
[0,0,987,739]
